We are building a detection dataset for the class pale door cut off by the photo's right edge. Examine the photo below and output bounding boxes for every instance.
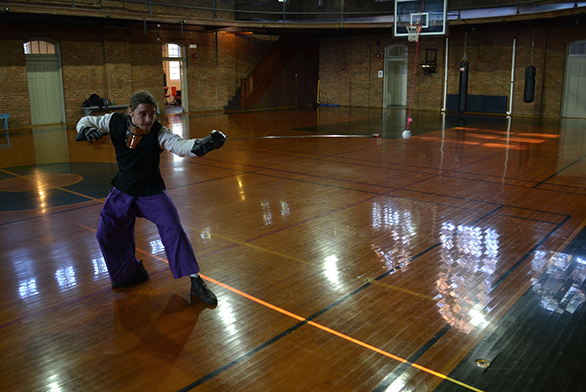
[562,40,586,118]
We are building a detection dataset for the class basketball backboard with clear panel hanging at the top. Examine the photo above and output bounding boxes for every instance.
[393,0,448,37]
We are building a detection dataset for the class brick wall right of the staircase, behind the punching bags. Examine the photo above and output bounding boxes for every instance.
[320,25,586,117]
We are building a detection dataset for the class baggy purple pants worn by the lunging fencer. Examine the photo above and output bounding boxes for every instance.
[96,188,199,283]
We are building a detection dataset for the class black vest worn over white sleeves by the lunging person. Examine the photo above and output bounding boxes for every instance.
[110,113,165,197]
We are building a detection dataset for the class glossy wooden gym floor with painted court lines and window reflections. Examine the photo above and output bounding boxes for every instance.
[0,107,586,392]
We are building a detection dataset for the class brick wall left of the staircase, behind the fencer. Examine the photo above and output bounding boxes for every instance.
[0,18,278,127]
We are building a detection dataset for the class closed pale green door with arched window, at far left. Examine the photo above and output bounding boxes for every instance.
[24,40,65,125]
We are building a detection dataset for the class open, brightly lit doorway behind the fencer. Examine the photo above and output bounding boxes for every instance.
[163,43,189,113]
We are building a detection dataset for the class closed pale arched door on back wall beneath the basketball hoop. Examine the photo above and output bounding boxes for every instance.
[383,45,409,108]
